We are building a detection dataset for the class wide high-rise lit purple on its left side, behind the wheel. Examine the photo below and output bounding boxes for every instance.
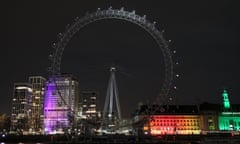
[44,74,79,134]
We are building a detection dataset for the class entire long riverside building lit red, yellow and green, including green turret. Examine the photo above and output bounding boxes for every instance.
[133,90,240,135]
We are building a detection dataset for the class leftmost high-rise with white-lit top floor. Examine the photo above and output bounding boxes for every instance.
[11,83,32,133]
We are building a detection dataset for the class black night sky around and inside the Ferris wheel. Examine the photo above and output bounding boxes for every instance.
[4,0,240,117]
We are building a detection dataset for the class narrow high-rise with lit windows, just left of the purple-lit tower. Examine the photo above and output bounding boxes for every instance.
[28,76,46,132]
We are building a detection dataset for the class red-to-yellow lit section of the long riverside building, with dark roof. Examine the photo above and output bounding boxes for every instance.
[135,105,201,135]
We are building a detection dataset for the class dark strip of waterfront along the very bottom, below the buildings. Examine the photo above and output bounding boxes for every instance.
[0,135,240,144]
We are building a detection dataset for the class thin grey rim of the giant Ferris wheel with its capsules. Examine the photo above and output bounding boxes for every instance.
[48,7,174,117]
